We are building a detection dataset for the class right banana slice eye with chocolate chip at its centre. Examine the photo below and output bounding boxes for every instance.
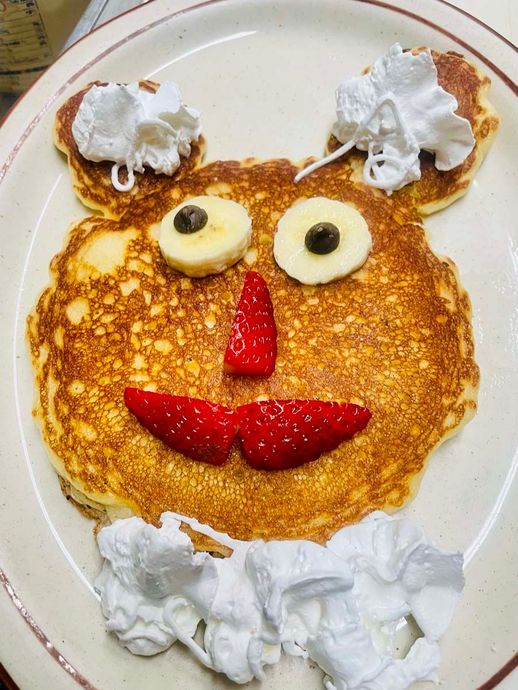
[273,196,372,285]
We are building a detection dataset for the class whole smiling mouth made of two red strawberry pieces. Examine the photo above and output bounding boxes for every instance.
[124,388,371,470]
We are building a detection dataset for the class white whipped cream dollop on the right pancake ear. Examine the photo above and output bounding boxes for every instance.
[295,43,475,189]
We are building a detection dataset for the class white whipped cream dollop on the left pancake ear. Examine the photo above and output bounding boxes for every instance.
[72,81,200,192]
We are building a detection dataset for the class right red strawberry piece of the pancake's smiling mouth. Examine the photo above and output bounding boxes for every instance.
[236,400,371,470]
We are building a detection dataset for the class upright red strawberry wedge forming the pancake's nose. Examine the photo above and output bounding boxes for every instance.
[224,271,277,376]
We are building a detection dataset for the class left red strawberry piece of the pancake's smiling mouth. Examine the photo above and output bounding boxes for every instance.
[124,388,237,465]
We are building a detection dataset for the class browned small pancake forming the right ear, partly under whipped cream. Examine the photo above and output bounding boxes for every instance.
[394,51,500,215]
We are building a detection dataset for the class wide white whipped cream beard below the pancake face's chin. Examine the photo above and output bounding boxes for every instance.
[95,512,464,690]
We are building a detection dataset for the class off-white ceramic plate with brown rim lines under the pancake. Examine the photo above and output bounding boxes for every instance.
[0,0,518,690]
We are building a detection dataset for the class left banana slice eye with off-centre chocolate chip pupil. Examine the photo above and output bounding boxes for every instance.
[158,196,252,278]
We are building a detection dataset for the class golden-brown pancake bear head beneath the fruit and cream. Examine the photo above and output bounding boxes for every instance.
[28,48,496,546]
